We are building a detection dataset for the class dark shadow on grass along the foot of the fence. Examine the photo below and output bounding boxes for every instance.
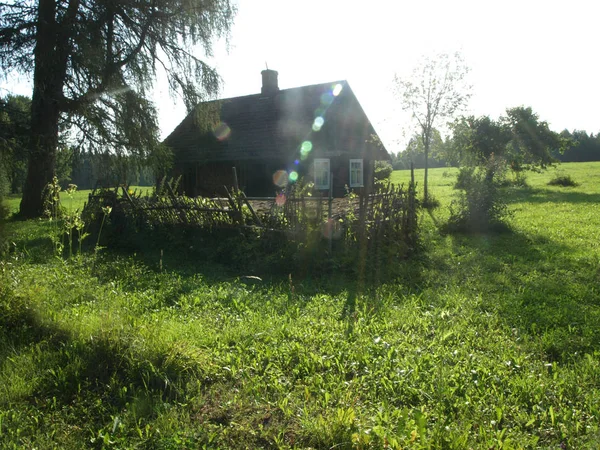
[100,225,422,297]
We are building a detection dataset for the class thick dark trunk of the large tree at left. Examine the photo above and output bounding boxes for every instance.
[20,0,66,218]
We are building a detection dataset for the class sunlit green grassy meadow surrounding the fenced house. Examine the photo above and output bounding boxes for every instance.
[0,162,600,449]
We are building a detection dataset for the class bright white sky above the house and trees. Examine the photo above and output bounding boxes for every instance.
[2,0,600,152]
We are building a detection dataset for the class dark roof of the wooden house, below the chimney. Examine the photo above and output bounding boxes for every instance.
[165,81,389,163]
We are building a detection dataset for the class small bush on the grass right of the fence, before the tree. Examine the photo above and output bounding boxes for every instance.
[447,158,509,232]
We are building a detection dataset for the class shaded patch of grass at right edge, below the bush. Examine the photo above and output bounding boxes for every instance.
[446,232,600,361]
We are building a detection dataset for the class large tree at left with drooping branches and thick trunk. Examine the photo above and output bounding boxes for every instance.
[0,0,235,216]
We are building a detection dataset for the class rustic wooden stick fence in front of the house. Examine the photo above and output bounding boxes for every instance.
[84,179,417,245]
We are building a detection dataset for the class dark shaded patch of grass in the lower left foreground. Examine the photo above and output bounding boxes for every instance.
[0,297,211,412]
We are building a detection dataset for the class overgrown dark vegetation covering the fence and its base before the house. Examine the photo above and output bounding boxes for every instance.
[83,183,418,278]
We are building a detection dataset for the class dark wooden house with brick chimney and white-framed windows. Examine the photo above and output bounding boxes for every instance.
[165,70,390,197]
